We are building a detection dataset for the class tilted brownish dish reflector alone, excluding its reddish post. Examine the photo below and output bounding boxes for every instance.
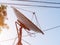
[12,7,44,34]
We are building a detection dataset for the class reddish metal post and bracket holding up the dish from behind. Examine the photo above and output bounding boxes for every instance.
[15,20,29,45]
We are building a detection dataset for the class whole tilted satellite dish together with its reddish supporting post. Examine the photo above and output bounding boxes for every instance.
[12,7,44,45]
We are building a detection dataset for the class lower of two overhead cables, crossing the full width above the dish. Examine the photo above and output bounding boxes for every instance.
[0,3,60,9]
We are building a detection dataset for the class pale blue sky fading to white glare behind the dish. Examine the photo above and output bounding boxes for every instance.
[0,0,60,45]
